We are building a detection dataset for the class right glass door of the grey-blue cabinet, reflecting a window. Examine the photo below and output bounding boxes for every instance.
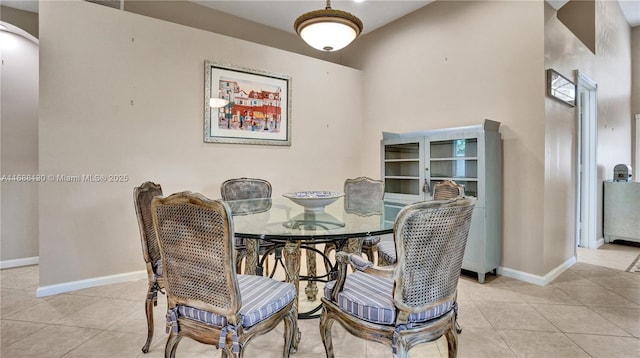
[429,138,478,197]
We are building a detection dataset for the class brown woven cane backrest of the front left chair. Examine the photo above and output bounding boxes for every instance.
[151,192,242,325]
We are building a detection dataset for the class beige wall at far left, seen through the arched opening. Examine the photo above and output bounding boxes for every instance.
[0,26,40,267]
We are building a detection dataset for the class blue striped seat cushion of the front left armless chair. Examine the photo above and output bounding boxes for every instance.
[178,275,296,328]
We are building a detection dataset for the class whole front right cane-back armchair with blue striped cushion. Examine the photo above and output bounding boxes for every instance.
[320,198,475,358]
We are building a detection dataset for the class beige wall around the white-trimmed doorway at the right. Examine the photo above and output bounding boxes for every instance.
[545,1,632,260]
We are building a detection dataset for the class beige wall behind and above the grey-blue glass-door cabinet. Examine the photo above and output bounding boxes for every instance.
[345,1,546,275]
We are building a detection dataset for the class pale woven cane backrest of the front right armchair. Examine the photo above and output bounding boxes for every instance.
[393,197,476,320]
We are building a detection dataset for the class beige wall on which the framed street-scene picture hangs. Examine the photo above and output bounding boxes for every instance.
[39,1,364,286]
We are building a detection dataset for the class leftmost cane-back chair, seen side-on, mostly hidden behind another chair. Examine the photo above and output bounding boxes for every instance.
[133,181,164,353]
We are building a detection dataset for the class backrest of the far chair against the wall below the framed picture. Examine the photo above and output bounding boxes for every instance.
[220,178,271,215]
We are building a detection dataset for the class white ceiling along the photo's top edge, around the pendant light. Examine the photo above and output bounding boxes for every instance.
[2,0,640,29]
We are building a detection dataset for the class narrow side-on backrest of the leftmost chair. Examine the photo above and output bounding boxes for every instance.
[133,181,162,267]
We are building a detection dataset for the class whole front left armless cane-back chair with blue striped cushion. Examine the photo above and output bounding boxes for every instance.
[151,192,297,358]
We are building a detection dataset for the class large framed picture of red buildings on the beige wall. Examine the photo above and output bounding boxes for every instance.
[204,61,291,145]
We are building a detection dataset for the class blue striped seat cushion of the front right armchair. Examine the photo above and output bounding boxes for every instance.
[324,271,453,325]
